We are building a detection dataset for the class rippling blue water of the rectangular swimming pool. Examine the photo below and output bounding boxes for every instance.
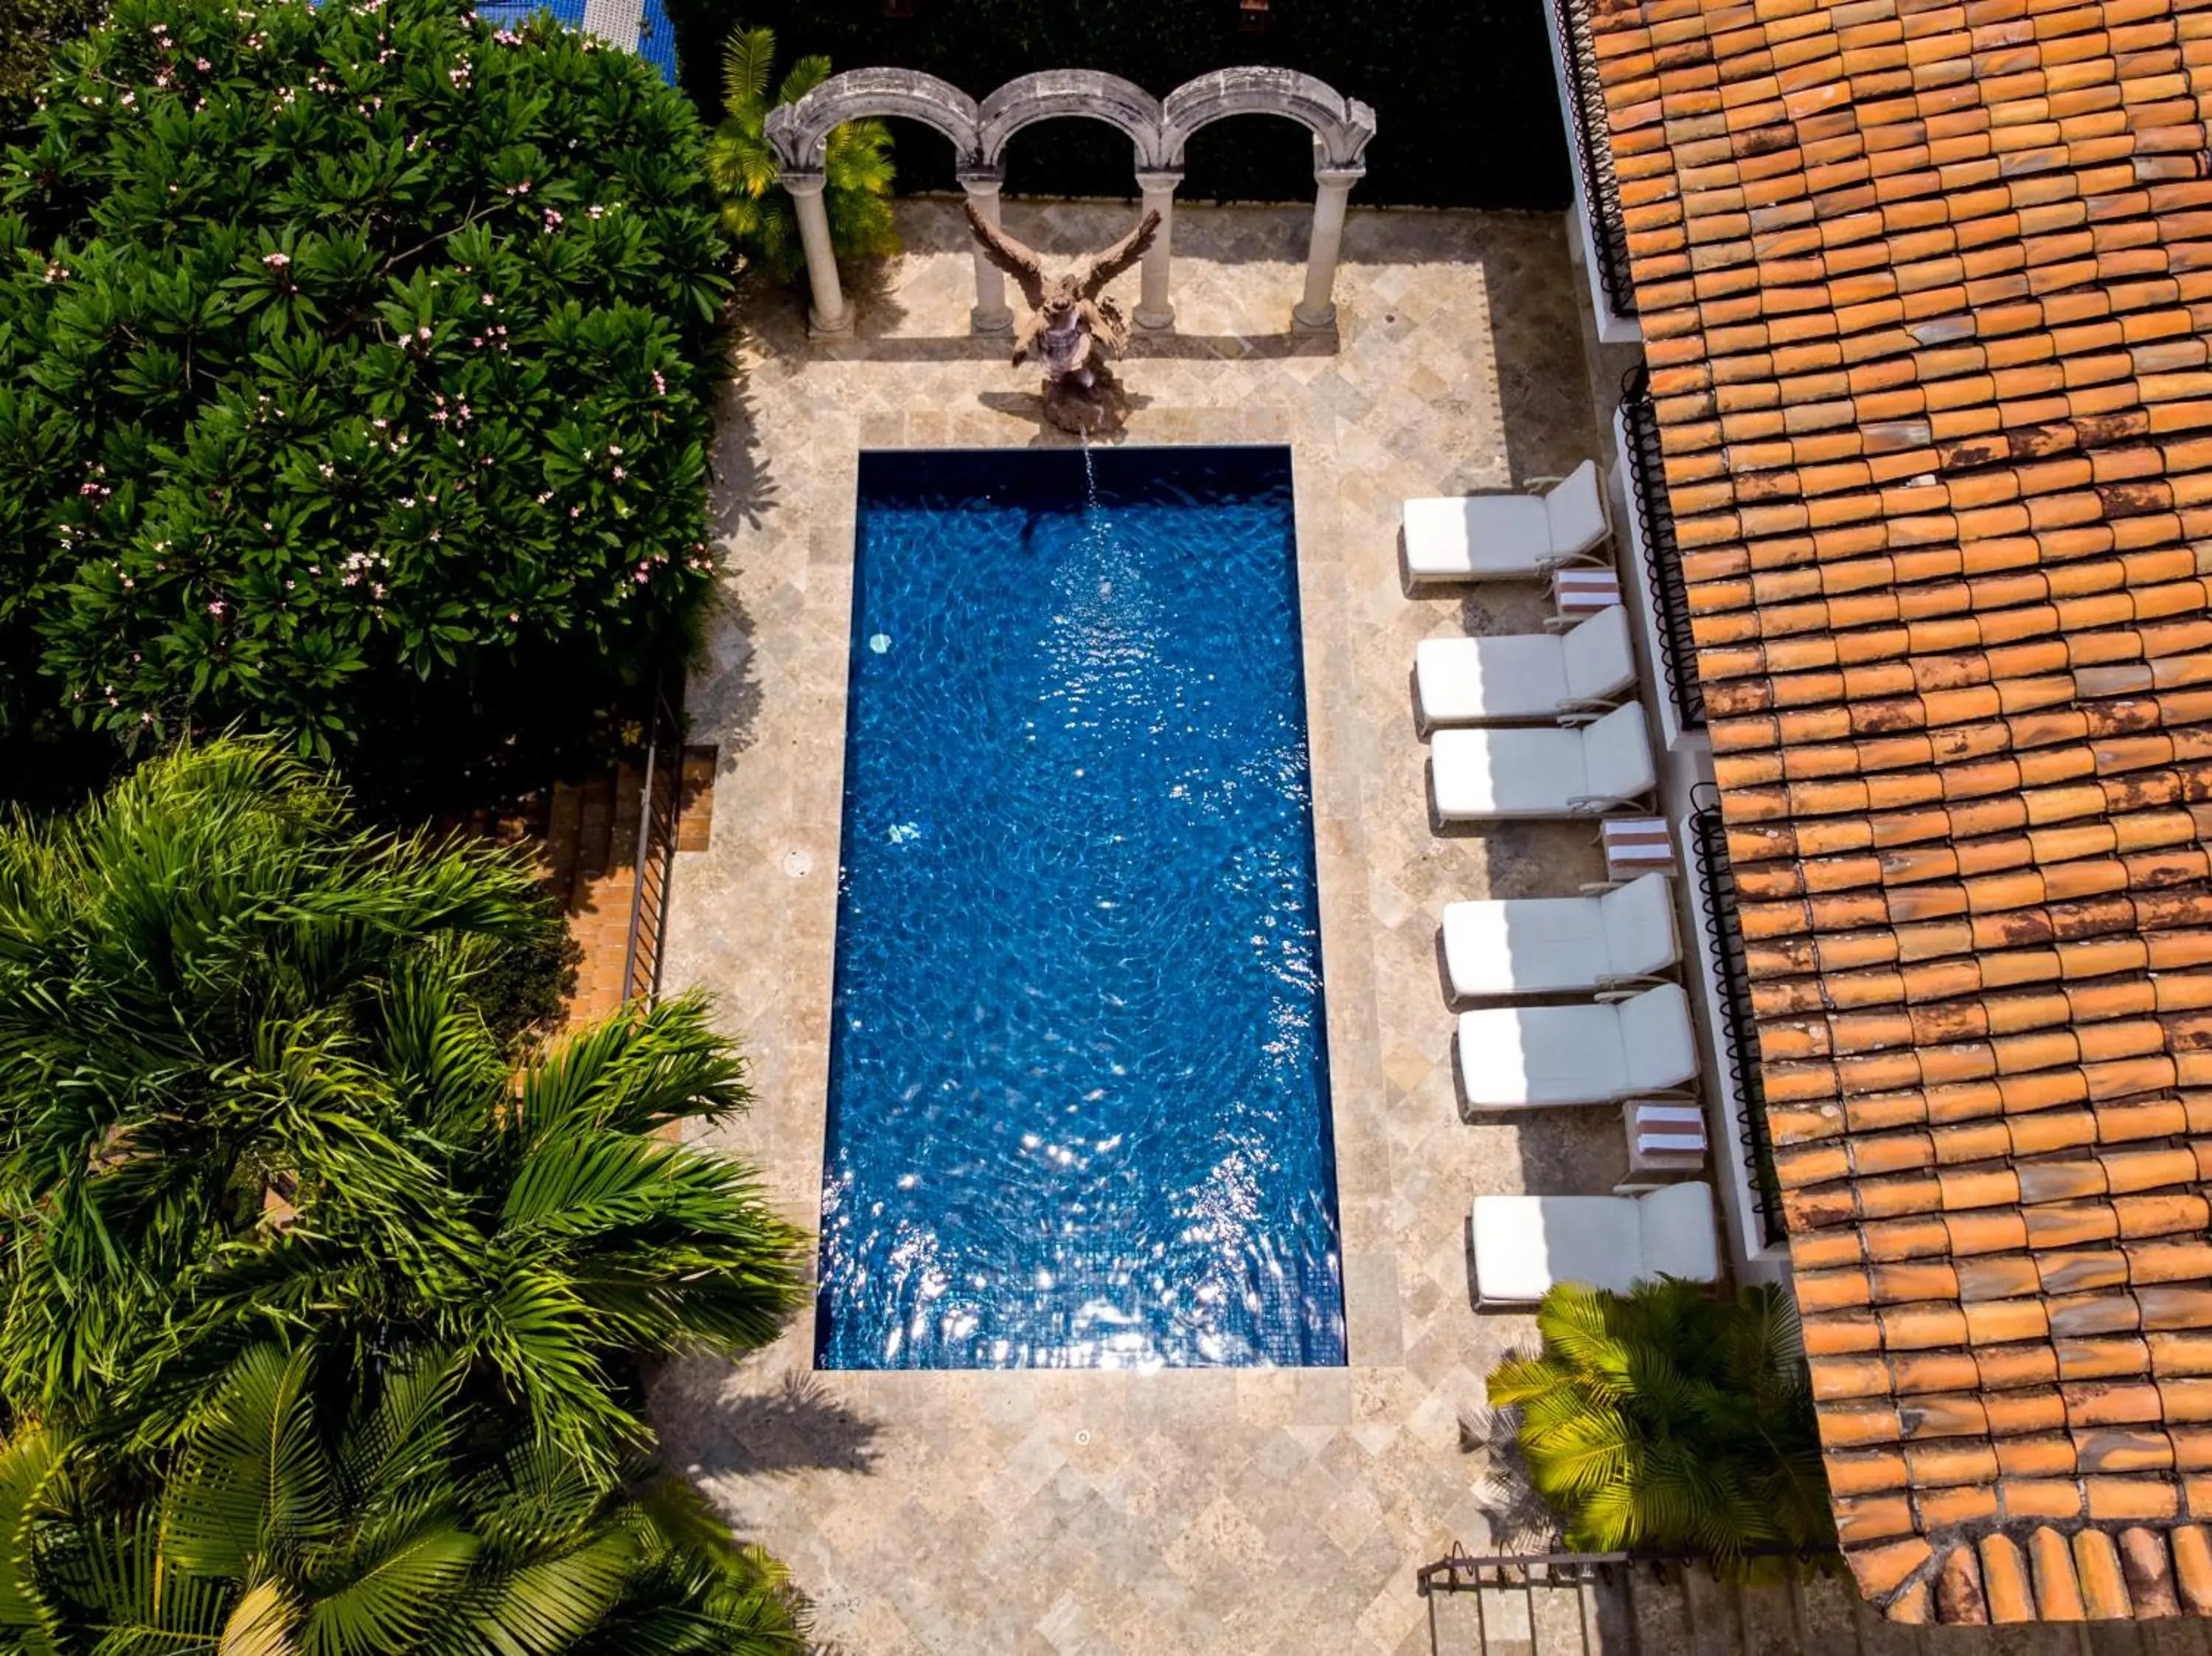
[816,449,1345,1368]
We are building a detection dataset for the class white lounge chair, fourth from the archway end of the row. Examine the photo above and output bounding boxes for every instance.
[1444,873,1681,999]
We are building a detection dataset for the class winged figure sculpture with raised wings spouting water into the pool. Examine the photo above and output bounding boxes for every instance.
[967,201,1159,434]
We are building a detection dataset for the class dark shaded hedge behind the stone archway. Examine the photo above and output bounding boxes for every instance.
[668,0,1571,210]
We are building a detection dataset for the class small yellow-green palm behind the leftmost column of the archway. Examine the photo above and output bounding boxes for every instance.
[706,24,898,281]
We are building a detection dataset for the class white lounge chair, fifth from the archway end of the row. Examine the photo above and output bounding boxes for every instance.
[1460,984,1697,1110]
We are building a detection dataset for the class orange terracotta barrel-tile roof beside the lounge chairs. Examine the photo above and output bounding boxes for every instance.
[1593,0,2212,1621]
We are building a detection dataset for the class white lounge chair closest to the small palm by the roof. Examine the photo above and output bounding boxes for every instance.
[1473,1183,1721,1311]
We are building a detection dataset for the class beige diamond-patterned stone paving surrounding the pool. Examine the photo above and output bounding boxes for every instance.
[655,201,1624,1656]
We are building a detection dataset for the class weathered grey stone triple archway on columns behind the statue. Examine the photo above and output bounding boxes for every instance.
[768,69,1376,334]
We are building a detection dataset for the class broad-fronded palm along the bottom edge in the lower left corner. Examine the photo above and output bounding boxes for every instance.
[0,1344,805,1656]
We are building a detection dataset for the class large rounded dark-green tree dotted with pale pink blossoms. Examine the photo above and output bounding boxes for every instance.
[0,0,728,752]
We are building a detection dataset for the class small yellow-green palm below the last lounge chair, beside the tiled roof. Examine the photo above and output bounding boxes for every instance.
[1491,1278,1836,1568]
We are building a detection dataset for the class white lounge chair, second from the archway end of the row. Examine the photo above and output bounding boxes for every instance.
[1413,604,1637,730]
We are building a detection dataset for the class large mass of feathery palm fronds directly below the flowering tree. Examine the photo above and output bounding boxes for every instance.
[0,741,803,1470]
